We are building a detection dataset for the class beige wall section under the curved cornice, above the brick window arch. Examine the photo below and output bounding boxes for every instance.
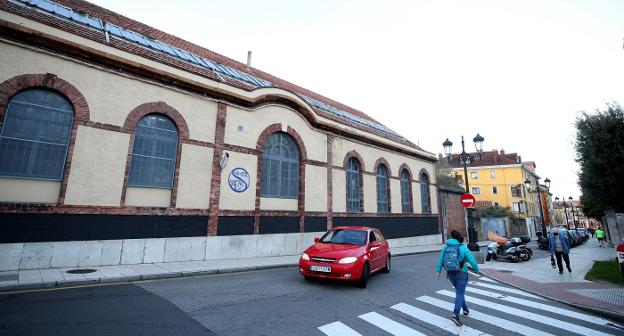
[224,105,327,162]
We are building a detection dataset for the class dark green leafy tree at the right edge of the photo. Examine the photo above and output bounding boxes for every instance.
[574,102,624,214]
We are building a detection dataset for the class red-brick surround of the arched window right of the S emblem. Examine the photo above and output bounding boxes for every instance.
[254,123,308,234]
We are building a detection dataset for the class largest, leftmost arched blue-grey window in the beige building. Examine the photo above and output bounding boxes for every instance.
[0,89,74,181]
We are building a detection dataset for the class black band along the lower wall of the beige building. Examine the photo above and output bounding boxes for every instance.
[0,214,439,243]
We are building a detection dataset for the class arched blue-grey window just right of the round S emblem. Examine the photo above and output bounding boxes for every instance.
[261,132,299,199]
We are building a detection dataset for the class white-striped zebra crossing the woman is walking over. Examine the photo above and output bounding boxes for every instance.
[318,277,624,336]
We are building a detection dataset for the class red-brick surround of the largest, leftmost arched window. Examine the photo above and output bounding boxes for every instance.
[0,73,91,205]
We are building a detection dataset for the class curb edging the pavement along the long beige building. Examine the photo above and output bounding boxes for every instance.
[0,249,439,295]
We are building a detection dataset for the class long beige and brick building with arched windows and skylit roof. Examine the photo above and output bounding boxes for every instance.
[0,0,441,270]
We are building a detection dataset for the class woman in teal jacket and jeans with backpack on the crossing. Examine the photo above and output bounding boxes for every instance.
[436,230,479,326]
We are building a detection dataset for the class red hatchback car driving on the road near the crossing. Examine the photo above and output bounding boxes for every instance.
[299,226,391,288]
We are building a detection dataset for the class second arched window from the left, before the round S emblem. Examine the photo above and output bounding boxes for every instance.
[128,114,178,189]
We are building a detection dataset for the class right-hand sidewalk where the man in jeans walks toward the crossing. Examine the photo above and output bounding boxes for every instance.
[479,238,624,321]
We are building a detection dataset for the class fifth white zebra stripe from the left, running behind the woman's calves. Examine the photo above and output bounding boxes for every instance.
[437,290,611,336]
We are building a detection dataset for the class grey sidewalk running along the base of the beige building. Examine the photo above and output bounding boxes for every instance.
[0,244,442,293]
